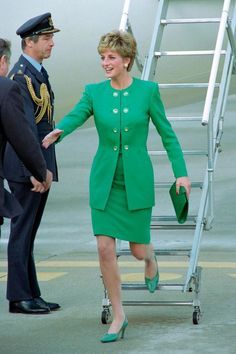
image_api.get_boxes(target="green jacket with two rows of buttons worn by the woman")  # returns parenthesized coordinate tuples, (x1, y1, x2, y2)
(57, 78, 187, 210)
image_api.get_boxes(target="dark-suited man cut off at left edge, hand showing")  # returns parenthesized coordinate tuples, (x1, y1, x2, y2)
(0, 38, 52, 233)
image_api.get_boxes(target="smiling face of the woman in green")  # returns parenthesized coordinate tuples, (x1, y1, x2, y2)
(101, 49, 130, 79)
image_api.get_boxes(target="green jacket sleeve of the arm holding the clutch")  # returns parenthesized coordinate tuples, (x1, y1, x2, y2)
(150, 84, 187, 178)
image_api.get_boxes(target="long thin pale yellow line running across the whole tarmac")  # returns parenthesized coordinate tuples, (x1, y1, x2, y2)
(0, 260, 236, 269)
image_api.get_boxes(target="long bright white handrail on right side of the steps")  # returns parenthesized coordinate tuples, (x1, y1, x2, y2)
(202, 0, 231, 125)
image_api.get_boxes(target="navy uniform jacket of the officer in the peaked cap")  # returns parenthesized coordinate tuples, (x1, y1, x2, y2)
(4, 56, 57, 182)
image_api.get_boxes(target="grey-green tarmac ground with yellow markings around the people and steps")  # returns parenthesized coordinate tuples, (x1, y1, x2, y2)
(0, 96, 236, 354)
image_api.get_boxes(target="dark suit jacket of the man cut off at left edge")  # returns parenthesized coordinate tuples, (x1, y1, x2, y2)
(0, 77, 46, 217)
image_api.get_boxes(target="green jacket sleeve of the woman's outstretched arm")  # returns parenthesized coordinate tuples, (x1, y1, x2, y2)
(56, 86, 93, 142)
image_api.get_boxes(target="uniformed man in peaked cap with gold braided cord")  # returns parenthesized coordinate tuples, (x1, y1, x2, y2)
(4, 13, 60, 314)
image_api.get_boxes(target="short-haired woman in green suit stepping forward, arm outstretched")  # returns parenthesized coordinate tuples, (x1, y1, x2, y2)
(43, 31, 190, 342)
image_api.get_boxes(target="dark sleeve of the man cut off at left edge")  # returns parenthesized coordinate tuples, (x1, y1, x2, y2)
(2, 82, 46, 182)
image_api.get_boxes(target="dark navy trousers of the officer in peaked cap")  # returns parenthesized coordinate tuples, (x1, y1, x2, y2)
(7, 182, 48, 301)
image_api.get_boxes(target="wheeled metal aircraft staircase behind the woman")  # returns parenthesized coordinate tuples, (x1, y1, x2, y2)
(102, 0, 236, 324)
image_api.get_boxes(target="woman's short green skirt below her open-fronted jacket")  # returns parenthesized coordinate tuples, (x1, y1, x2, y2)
(91, 154, 152, 244)
